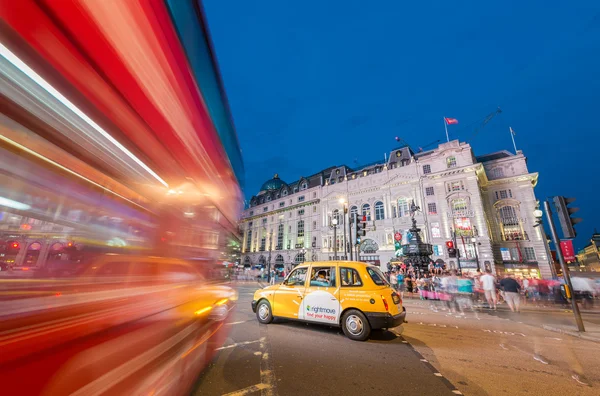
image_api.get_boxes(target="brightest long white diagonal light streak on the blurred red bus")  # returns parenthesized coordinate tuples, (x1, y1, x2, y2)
(0, 43, 169, 188)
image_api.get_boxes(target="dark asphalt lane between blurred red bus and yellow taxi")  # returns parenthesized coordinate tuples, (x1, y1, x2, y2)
(194, 285, 460, 396)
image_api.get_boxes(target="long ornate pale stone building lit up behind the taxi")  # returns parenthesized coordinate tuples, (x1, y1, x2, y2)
(240, 140, 551, 277)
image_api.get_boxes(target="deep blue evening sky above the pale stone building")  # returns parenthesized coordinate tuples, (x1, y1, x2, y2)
(204, 0, 600, 248)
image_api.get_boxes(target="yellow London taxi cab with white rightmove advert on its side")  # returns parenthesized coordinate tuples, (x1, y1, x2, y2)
(252, 261, 406, 341)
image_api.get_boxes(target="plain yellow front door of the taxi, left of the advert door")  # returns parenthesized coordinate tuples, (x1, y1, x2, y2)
(273, 267, 308, 319)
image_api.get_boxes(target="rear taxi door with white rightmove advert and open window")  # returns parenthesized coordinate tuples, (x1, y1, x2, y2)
(302, 264, 341, 325)
